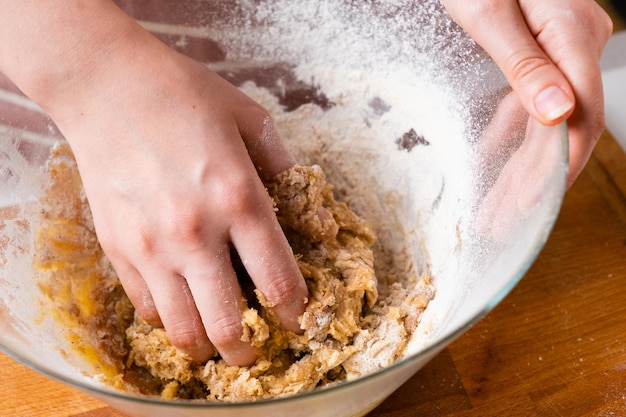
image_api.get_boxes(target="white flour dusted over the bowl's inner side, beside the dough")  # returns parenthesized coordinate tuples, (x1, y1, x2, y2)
(208, 0, 478, 352)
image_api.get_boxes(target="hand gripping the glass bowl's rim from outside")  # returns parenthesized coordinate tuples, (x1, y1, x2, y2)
(443, 0, 613, 186)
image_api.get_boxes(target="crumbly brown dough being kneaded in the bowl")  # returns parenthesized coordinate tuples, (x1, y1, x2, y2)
(36, 144, 434, 401)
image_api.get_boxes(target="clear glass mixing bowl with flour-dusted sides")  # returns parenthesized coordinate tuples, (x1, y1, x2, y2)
(0, 0, 568, 417)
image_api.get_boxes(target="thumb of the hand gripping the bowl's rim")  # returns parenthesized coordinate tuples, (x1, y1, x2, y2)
(445, 0, 575, 125)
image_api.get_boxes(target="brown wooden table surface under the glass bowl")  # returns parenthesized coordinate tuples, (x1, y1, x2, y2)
(0, 5, 626, 417)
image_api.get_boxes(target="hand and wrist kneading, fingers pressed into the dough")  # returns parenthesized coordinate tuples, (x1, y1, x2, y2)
(0, 0, 307, 365)
